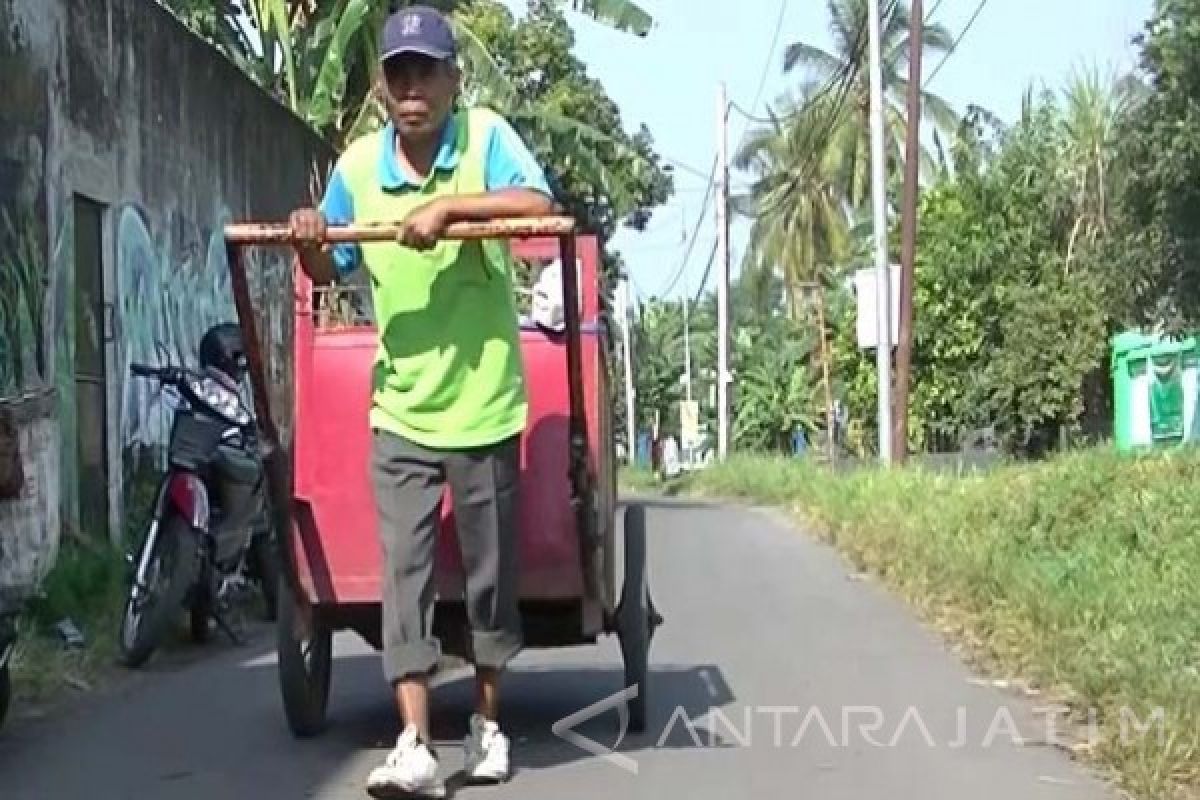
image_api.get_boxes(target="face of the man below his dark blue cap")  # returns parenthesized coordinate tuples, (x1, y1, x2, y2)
(383, 53, 458, 138)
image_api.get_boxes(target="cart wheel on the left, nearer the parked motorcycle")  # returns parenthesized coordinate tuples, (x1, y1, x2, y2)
(275, 577, 334, 738)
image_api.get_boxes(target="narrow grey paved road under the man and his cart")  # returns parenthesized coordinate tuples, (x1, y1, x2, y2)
(0, 503, 1108, 800)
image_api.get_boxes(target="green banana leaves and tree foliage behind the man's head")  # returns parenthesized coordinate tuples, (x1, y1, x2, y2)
(153, 0, 673, 245)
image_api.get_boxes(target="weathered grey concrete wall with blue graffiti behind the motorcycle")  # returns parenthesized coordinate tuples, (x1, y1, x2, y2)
(0, 0, 332, 575)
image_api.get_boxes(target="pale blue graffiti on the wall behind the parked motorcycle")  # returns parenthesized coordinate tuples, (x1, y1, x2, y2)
(115, 205, 292, 472)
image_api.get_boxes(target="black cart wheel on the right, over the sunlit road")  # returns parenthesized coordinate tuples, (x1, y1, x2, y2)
(617, 505, 659, 733)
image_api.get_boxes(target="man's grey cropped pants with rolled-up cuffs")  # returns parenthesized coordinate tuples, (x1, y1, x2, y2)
(371, 431, 522, 684)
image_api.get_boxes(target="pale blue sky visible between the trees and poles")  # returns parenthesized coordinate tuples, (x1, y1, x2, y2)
(506, 0, 1152, 295)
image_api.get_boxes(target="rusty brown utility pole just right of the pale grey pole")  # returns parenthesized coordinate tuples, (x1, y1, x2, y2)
(892, 0, 925, 463)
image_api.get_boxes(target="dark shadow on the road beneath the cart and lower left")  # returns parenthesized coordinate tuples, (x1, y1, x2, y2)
(7, 640, 736, 800)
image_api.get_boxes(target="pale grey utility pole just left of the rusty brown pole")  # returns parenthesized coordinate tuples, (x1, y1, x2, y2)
(866, 0, 892, 464)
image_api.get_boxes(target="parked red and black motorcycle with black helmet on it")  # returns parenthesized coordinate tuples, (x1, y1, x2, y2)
(119, 324, 280, 667)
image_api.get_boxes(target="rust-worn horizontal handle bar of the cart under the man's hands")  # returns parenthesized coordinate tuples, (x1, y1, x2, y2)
(224, 217, 575, 245)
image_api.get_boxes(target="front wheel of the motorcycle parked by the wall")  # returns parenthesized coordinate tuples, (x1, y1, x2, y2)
(118, 515, 199, 667)
